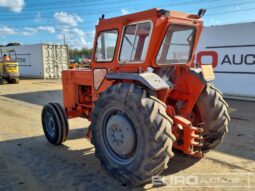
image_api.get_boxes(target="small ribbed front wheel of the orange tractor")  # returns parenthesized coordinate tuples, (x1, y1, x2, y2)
(41, 103, 69, 145)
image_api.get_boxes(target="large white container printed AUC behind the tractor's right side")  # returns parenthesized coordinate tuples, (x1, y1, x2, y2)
(197, 23, 255, 99)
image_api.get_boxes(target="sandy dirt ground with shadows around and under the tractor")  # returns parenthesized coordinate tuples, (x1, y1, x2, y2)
(0, 80, 255, 191)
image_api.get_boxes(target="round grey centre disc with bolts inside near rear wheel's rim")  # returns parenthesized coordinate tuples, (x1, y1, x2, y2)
(106, 113, 136, 159)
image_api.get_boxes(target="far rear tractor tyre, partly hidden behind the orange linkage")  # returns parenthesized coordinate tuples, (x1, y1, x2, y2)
(196, 84, 230, 152)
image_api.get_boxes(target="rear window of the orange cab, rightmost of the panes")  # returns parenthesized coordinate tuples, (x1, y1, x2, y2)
(157, 25, 196, 64)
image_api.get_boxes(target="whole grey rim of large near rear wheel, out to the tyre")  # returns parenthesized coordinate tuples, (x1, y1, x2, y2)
(103, 110, 139, 164)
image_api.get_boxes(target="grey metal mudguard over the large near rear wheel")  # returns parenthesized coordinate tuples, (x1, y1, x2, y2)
(106, 72, 172, 91)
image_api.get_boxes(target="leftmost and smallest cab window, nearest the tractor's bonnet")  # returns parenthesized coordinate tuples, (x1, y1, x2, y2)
(95, 30, 118, 62)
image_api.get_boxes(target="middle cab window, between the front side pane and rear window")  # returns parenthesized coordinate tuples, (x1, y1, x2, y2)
(119, 22, 152, 63)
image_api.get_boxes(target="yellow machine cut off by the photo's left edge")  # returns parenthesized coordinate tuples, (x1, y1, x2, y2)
(0, 50, 19, 84)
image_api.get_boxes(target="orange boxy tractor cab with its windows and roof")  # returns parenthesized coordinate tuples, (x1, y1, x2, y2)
(92, 9, 203, 72)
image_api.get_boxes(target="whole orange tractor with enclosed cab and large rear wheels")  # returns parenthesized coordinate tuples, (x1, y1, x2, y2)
(42, 9, 230, 185)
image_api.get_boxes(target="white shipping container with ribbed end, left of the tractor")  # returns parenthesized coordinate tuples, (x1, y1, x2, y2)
(2, 44, 69, 79)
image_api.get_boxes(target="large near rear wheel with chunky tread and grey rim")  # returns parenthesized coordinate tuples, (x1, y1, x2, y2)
(92, 83, 175, 185)
